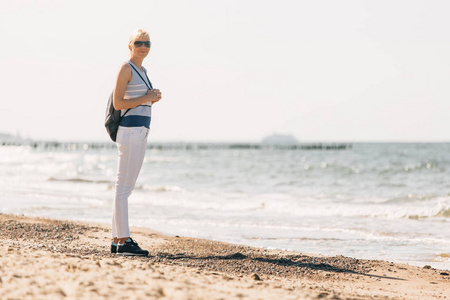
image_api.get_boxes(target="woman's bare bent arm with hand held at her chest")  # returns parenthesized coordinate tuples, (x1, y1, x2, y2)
(113, 64, 161, 110)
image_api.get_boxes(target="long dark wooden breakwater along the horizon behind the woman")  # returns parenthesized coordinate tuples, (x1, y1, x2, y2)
(0, 141, 352, 151)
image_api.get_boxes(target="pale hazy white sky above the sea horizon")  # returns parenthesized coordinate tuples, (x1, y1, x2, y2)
(0, 0, 450, 142)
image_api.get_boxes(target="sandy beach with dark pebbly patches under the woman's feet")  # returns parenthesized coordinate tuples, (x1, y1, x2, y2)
(0, 214, 450, 300)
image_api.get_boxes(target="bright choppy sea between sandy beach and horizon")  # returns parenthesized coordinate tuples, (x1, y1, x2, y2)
(0, 142, 450, 270)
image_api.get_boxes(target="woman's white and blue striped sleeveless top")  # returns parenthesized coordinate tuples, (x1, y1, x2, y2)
(119, 60, 152, 129)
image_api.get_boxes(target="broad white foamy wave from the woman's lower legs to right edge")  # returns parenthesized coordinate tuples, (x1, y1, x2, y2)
(126, 189, 450, 220)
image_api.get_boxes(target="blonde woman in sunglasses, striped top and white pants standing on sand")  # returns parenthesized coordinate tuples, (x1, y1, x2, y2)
(111, 30, 161, 256)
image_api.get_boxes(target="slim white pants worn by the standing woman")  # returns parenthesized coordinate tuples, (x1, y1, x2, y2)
(112, 126, 149, 238)
